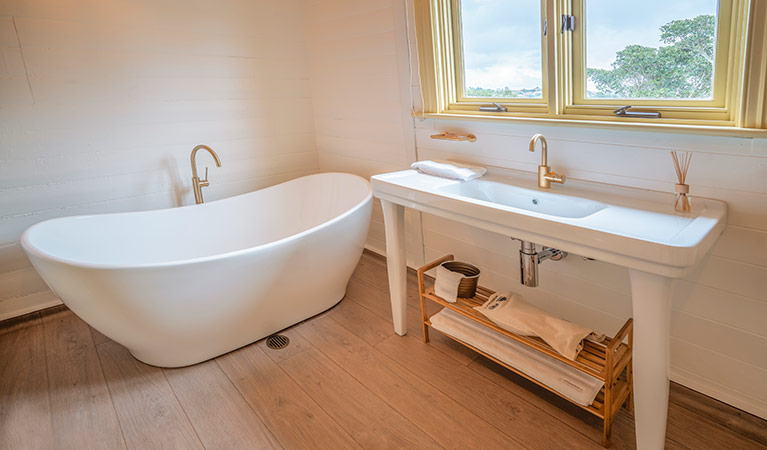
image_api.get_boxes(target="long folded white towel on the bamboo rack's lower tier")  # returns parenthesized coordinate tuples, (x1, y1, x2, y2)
(431, 308, 604, 406)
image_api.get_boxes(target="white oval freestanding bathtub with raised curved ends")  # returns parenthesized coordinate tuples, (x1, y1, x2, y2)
(21, 173, 372, 367)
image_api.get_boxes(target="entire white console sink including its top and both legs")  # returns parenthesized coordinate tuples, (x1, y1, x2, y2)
(371, 170, 727, 450)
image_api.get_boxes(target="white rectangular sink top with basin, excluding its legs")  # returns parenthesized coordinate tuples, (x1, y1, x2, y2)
(371, 170, 727, 278)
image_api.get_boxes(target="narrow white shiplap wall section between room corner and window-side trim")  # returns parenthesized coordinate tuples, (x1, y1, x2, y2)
(305, 0, 423, 264)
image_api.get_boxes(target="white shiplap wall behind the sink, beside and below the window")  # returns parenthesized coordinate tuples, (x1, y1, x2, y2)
(307, 0, 767, 417)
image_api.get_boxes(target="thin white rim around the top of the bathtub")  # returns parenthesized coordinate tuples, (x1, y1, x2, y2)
(20, 172, 373, 270)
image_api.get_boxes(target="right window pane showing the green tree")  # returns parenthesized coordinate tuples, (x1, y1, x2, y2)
(585, 0, 717, 100)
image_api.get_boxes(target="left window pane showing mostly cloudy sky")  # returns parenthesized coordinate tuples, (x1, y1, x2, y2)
(460, 0, 543, 98)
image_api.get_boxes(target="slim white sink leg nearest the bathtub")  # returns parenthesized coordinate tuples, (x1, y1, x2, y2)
(381, 200, 407, 336)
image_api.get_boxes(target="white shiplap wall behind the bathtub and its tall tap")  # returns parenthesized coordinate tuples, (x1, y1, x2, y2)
(0, 0, 318, 319)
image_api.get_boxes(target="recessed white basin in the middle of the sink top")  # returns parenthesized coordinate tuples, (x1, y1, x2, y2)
(438, 180, 607, 219)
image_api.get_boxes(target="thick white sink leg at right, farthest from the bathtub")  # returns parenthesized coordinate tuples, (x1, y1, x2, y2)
(629, 269, 671, 450)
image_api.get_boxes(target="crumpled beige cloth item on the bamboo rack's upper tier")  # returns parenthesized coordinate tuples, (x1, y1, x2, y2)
(474, 292, 605, 361)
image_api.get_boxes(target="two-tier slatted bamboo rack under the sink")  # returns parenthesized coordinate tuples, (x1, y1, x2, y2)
(418, 255, 634, 448)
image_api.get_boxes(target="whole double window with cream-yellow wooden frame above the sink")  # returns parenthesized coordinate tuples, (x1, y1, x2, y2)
(416, 0, 767, 132)
